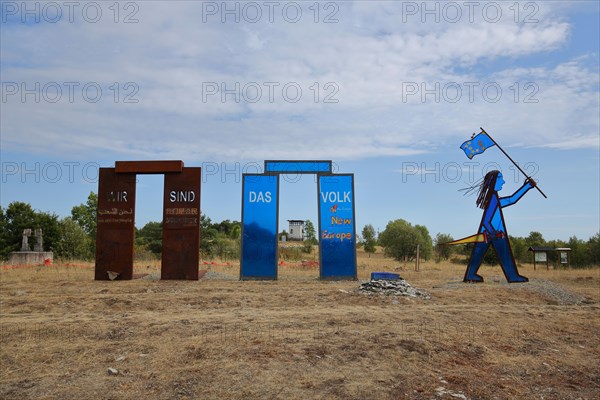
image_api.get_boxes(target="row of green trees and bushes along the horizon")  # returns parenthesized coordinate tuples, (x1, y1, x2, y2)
(0, 192, 600, 267)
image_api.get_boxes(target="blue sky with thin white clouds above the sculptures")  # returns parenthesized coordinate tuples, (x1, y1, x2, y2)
(0, 1, 600, 239)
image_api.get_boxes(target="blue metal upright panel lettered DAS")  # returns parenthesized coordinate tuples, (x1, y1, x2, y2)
(240, 174, 279, 279)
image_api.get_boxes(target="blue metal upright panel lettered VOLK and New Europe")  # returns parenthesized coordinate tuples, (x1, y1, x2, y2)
(318, 174, 356, 279)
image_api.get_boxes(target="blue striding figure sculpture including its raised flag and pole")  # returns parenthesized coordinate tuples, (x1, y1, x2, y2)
(444, 128, 546, 283)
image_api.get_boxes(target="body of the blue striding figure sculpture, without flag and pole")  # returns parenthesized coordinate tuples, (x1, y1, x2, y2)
(464, 170, 535, 283)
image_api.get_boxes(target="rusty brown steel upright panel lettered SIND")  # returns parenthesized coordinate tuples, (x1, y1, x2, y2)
(160, 167, 201, 280)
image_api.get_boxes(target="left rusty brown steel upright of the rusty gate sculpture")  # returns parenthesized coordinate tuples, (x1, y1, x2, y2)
(95, 168, 136, 280)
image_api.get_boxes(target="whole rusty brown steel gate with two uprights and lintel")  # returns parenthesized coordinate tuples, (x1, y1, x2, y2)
(95, 161, 201, 280)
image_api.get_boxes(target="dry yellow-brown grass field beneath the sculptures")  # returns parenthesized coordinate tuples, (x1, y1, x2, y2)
(0, 253, 600, 400)
